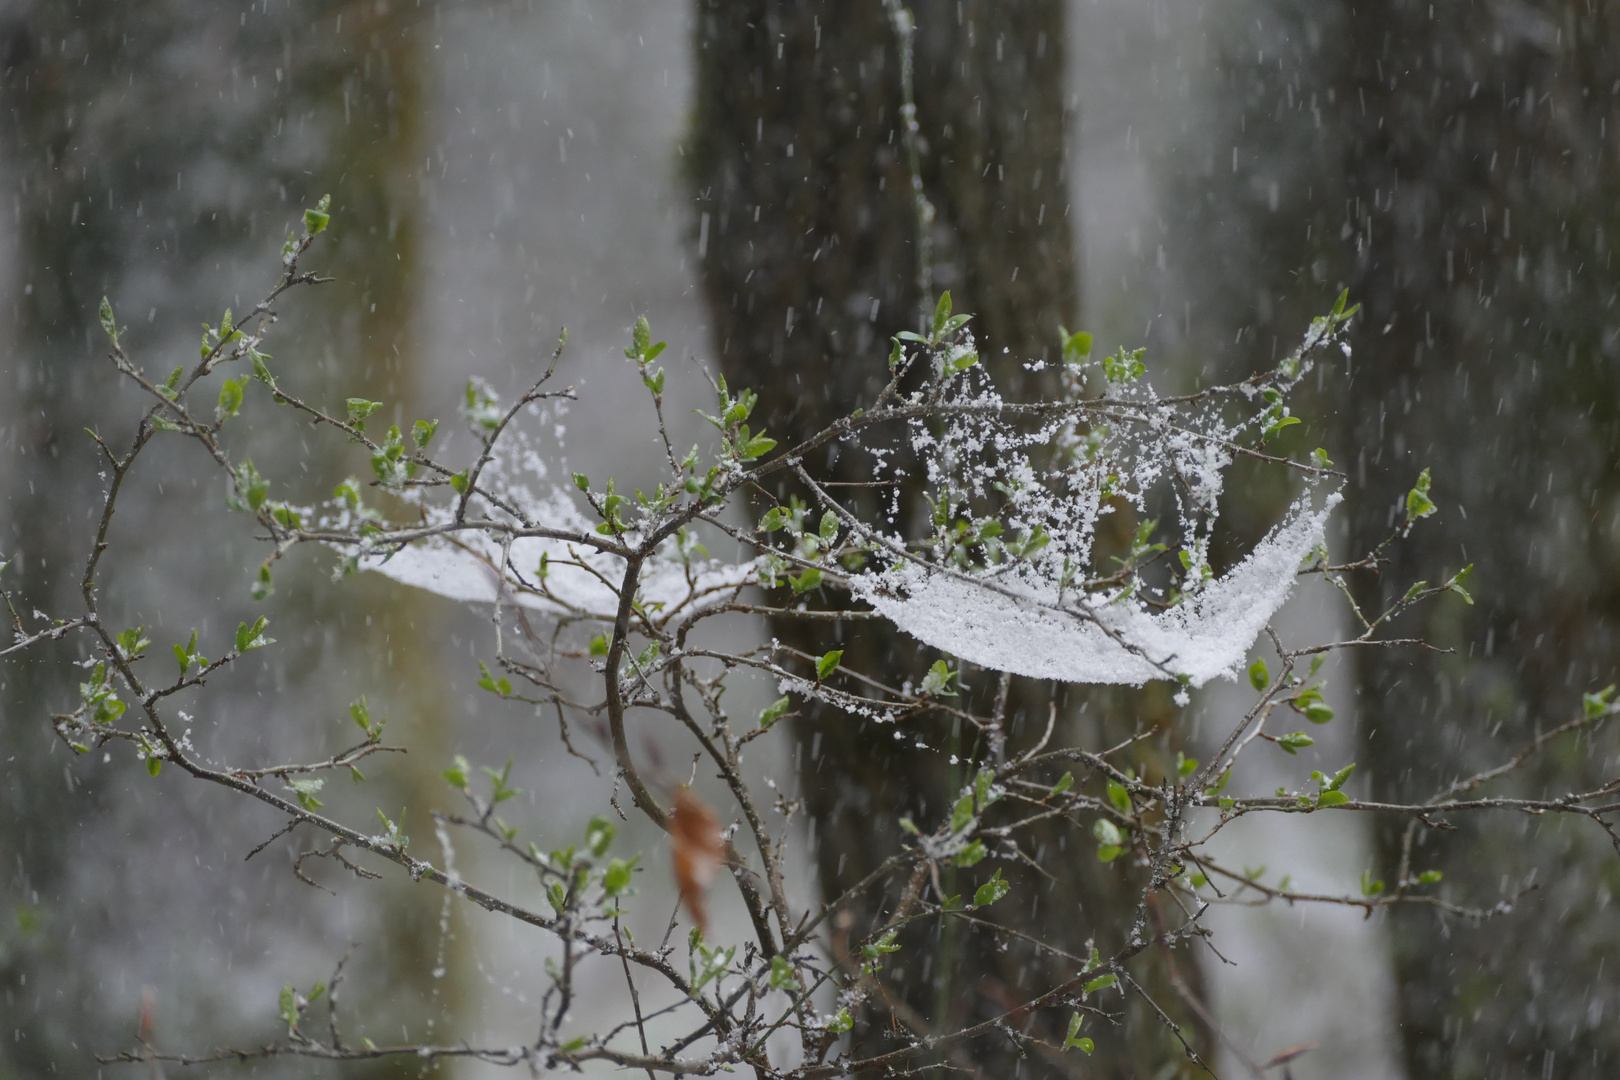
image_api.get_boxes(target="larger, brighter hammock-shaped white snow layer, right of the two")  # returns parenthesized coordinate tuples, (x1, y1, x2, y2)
(852, 494, 1340, 687)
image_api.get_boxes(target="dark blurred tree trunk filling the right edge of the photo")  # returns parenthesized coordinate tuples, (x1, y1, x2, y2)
(1348, 3, 1620, 1078)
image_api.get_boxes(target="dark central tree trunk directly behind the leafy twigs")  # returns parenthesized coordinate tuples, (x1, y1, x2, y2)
(687, 0, 1197, 1077)
